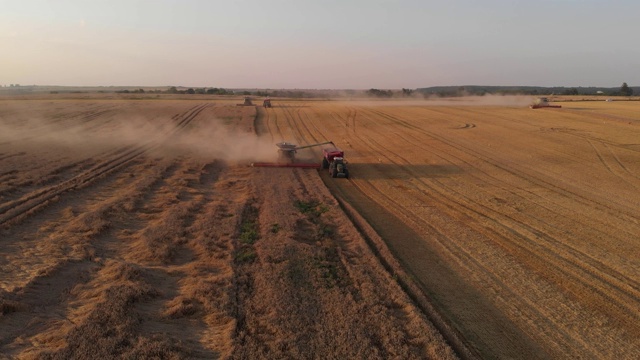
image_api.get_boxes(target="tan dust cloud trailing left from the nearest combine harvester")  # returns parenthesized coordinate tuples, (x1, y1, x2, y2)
(0, 113, 277, 163)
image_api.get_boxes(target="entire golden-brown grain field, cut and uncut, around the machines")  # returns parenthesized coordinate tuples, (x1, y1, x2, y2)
(0, 97, 640, 359)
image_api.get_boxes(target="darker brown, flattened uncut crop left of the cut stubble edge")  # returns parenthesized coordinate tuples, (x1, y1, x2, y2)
(0, 98, 460, 359)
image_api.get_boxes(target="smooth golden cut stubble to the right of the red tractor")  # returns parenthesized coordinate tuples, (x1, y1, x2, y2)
(267, 98, 640, 359)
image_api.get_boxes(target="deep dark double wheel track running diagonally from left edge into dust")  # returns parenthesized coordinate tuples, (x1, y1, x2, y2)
(0, 104, 209, 226)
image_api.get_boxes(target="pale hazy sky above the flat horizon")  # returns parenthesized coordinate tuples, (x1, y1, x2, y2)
(0, 0, 640, 89)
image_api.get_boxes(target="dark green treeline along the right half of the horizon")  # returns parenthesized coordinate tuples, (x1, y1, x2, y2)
(416, 83, 640, 97)
